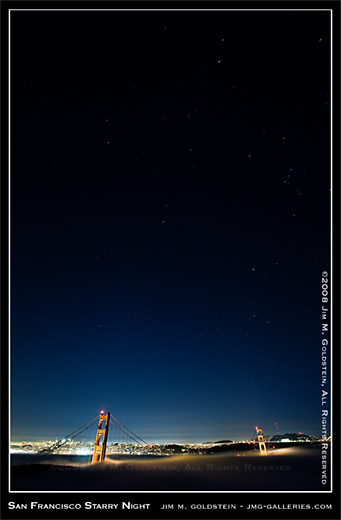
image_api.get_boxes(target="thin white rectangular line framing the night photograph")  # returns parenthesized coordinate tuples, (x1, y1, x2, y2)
(8, 9, 333, 494)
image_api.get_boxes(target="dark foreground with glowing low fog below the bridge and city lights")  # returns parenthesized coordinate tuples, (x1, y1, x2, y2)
(11, 446, 330, 491)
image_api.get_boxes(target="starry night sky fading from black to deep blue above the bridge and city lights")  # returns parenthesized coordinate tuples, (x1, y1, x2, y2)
(11, 11, 330, 442)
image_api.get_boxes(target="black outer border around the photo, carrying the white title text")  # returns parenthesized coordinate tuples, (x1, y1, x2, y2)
(1, 0, 341, 520)
